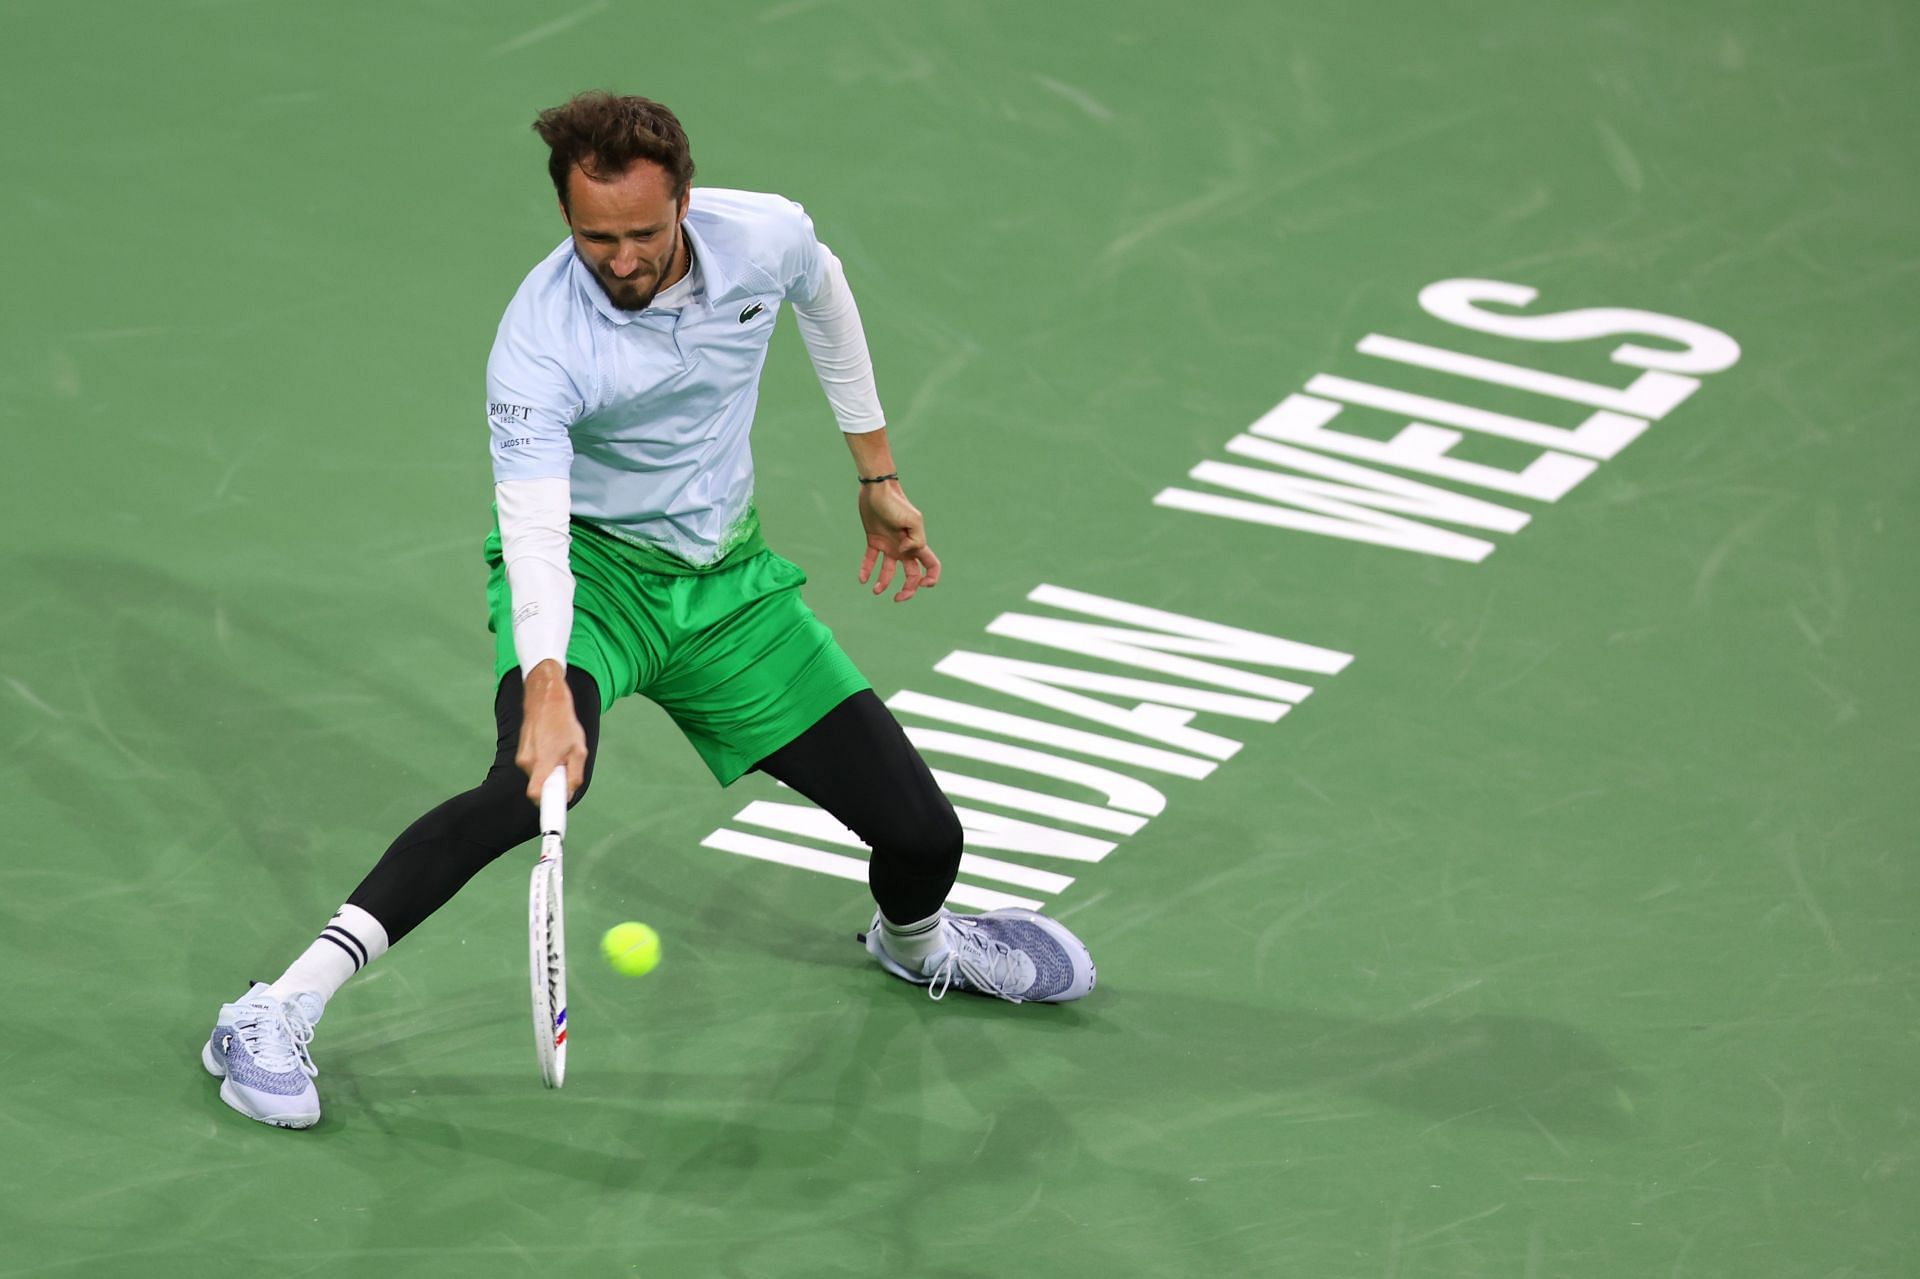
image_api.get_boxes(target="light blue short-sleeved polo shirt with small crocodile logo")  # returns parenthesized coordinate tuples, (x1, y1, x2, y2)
(486, 186, 829, 567)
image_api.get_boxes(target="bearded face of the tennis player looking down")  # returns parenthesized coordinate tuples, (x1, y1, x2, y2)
(561, 159, 687, 311)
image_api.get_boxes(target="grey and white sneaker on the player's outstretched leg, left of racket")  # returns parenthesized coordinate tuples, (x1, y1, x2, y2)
(200, 981, 323, 1127)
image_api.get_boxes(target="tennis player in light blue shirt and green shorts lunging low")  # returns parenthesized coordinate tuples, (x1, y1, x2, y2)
(202, 92, 1094, 1127)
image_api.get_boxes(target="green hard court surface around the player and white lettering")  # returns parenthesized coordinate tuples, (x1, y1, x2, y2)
(0, 0, 1920, 1279)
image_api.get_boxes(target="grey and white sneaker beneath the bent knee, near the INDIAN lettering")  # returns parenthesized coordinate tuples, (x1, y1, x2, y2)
(860, 908, 1094, 1004)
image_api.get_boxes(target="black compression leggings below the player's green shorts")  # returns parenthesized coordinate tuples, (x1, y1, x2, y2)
(348, 668, 962, 943)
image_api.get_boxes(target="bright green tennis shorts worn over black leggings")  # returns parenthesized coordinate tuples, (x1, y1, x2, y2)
(486, 520, 872, 785)
